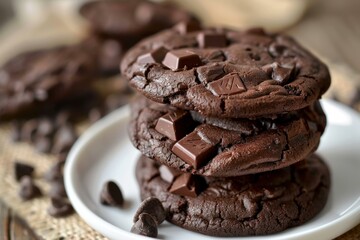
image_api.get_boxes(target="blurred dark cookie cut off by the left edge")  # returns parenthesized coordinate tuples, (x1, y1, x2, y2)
(0, 45, 95, 119)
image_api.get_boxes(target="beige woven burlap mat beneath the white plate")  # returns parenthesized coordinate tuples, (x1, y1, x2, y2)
(0, 62, 360, 240)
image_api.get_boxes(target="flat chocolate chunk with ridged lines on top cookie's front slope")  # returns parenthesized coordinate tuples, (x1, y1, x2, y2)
(208, 73, 246, 96)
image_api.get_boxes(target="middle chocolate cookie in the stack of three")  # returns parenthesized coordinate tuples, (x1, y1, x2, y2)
(129, 97, 326, 177)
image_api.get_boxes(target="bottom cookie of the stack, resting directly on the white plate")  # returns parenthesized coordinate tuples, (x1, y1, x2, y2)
(136, 155, 330, 237)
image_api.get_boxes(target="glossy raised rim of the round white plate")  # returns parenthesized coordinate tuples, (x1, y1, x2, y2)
(64, 99, 360, 240)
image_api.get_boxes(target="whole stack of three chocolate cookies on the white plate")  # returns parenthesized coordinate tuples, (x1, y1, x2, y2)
(121, 22, 330, 236)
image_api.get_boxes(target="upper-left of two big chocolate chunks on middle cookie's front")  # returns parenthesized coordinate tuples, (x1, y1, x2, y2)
(155, 110, 194, 141)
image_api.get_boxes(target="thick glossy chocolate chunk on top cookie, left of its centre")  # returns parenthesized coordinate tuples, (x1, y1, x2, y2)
(162, 49, 201, 71)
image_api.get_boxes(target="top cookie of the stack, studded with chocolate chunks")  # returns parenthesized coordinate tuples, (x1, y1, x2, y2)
(121, 23, 330, 118)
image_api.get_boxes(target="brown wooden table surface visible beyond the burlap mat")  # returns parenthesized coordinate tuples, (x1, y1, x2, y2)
(0, 0, 360, 240)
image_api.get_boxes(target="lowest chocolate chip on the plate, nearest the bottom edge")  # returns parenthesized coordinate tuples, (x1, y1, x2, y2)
(131, 213, 158, 238)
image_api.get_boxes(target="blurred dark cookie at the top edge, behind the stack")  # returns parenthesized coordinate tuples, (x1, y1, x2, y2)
(80, 0, 198, 42)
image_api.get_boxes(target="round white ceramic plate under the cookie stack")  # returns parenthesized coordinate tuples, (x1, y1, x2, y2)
(65, 101, 360, 240)
